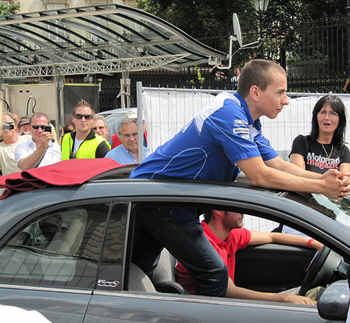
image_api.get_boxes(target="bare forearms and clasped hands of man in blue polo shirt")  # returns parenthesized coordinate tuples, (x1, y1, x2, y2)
(237, 157, 347, 199)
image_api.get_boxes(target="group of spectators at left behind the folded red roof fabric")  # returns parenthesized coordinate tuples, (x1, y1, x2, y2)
(0, 100, 147, 176)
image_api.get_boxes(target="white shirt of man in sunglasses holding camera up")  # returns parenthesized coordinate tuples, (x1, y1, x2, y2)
(15, 139, 61, 167)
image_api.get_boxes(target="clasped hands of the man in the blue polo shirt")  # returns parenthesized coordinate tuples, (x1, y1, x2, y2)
(321, 169, 350, 201)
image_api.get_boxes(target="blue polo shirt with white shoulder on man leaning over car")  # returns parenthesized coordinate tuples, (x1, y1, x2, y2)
(130, 92, 277, 221)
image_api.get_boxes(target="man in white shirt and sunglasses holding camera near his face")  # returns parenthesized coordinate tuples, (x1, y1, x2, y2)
(15, 112, 61, 170)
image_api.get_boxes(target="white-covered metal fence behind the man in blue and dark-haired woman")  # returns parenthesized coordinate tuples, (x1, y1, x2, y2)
(138, 87, 350, 160)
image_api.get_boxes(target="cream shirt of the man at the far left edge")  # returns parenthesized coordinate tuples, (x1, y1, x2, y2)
(0, 135, 32, 175)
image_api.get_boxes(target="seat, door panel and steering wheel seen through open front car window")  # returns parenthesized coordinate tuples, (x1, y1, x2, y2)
(128, 206, 349, 302)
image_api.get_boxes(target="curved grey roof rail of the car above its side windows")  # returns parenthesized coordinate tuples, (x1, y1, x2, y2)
(0, 174, 350, 254)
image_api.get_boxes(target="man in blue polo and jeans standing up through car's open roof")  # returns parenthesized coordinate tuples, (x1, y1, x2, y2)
(130, 59, 348, 296)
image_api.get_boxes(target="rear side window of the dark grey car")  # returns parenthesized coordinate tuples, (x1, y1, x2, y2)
(0, 203, 109, 288)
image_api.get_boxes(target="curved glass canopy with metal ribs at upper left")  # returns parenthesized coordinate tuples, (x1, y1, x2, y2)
(0, 4, 227, 78)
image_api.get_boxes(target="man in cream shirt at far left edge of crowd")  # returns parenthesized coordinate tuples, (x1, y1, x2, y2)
(0, 112, 32, 175)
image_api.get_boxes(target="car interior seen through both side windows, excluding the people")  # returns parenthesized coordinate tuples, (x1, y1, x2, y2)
(0, 202, 349, 308)
